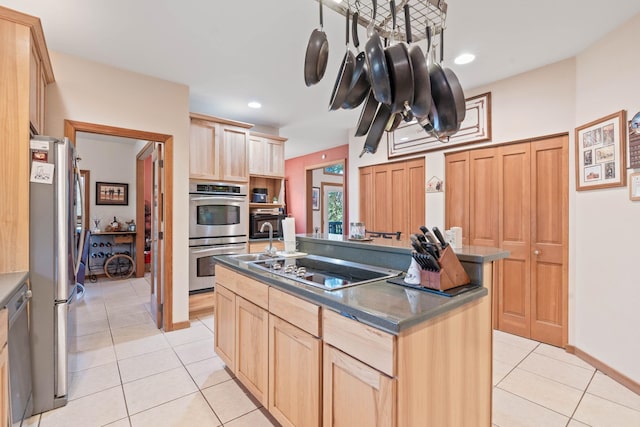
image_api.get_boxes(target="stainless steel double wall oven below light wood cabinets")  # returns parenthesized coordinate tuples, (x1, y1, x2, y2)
(189, 182, 249, 293)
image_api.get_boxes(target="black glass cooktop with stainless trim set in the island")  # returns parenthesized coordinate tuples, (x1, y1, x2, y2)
(244, 254, 401, 291)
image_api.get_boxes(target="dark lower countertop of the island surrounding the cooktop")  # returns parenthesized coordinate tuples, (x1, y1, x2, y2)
(216, 255, 488, 335)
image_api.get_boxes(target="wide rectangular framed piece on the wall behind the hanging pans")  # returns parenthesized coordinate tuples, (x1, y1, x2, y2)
(387, 92, 491, 158)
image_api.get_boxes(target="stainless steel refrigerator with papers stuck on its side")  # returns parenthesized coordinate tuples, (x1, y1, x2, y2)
(29, 137, 84, 413)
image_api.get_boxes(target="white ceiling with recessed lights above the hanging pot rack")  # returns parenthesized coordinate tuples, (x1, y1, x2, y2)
(5, 0, 640, 158)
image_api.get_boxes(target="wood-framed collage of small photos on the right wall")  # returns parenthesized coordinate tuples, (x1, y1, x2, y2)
(575, 110, 627, 191)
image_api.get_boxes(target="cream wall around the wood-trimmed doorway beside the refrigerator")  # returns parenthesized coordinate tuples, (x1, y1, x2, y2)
(45, 51, 189, 322)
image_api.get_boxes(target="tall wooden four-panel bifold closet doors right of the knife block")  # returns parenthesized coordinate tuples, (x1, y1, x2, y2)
(445, 135, 569, 346)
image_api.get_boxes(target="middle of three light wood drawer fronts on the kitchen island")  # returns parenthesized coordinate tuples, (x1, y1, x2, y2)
(269, 288, 320, 337)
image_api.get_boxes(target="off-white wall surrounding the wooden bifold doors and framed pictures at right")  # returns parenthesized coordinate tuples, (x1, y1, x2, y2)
(348, 15, 640, 382)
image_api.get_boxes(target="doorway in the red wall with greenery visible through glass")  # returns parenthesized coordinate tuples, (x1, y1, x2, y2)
(305, 159, 348, 234)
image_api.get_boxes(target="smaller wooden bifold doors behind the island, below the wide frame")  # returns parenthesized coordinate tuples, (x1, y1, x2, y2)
(359, 158, 425, 236)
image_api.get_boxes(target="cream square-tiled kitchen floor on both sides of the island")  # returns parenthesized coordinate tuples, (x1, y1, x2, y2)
(26, 279, 640, 427)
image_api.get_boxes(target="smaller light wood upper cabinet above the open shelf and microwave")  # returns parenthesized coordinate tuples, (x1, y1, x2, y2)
(249, 132, 287, 178)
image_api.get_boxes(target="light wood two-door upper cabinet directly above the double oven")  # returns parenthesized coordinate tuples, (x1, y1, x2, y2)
(189, 113, 253, 182)
